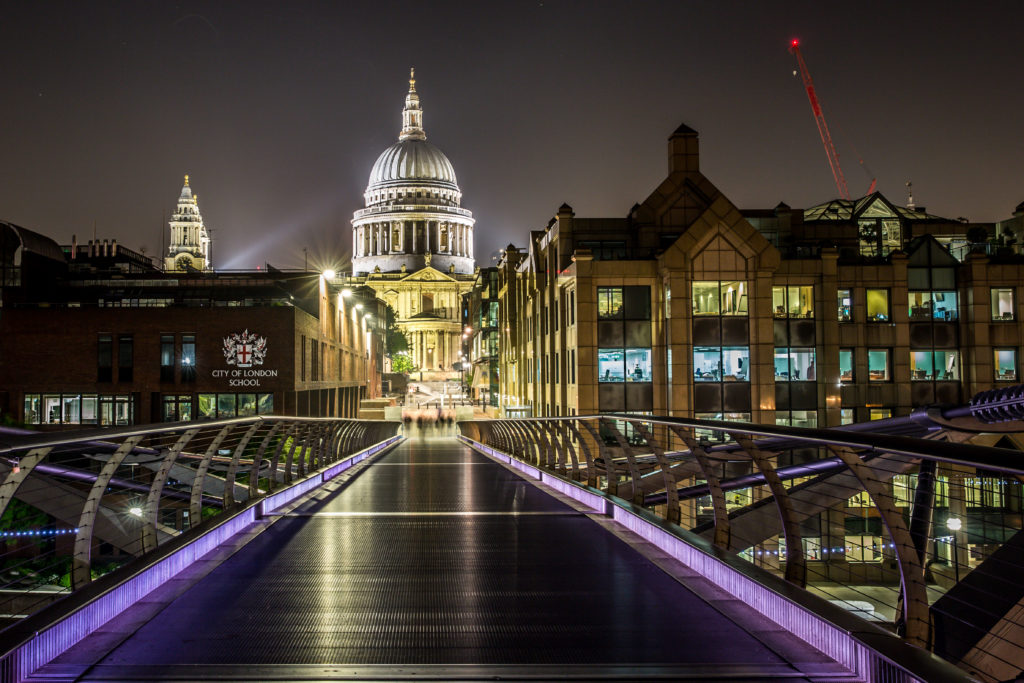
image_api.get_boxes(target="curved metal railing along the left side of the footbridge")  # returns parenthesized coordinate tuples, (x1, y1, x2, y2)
(0, 416, 400, 627)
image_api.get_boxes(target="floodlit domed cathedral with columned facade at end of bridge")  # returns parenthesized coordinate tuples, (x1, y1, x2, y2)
(352, 74, 475, 372)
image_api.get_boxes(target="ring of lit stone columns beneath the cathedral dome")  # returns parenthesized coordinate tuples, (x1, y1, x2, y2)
(354, 220, 473, 258)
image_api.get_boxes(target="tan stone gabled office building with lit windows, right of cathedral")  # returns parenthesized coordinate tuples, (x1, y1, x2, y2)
(498, 120, 1024, 426)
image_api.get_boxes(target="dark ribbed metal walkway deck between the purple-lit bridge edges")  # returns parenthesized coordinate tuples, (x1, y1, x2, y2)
(29, 436, 843, 681)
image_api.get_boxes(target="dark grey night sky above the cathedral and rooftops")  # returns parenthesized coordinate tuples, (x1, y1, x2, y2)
(0, 0, 1024, 268)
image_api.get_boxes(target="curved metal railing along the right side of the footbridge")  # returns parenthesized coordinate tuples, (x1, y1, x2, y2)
(459, 397, 1024, 681)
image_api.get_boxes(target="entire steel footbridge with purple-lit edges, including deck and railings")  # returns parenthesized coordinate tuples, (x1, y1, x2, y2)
(0, 387, 1024, 682)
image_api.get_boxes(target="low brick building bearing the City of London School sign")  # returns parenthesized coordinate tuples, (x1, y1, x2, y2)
(0, 223, 383, 428)
